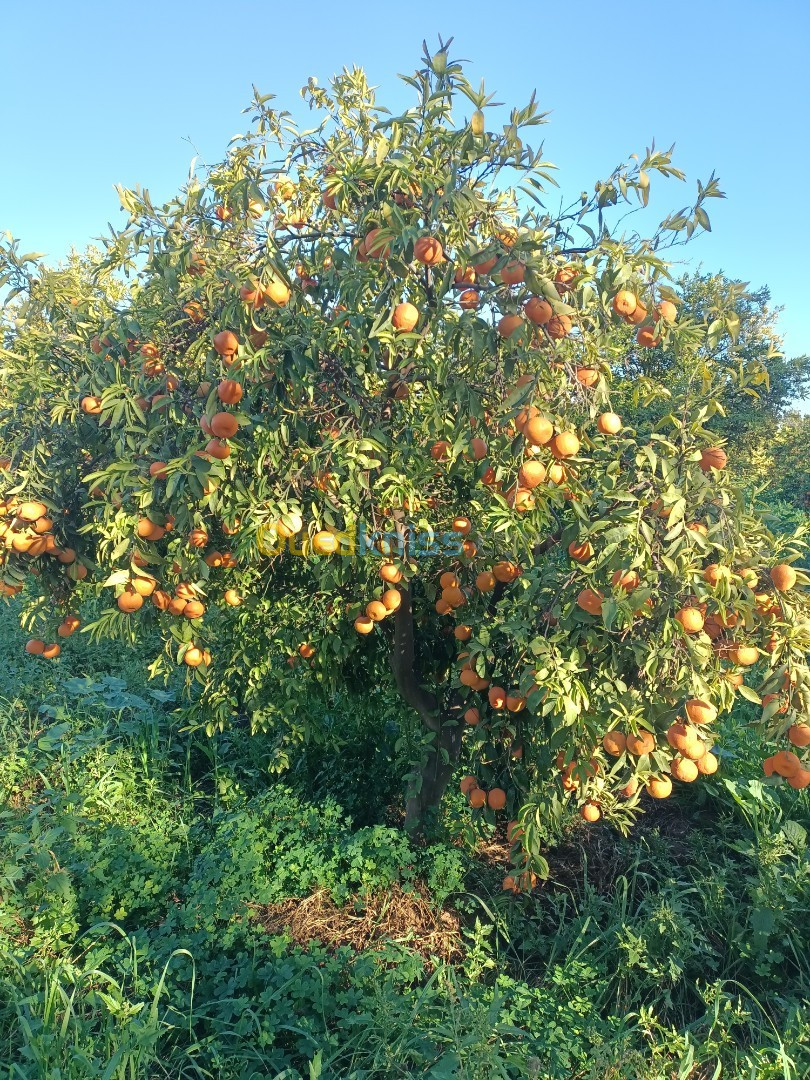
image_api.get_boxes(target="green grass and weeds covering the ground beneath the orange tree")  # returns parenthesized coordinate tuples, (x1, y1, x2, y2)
(0, 608, 810, 1080)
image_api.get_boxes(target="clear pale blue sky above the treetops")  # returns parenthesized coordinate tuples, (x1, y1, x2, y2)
(0, 0, 810, 365)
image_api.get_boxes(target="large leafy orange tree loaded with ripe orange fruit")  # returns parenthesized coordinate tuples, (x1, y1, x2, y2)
(0, 46, 810, 887)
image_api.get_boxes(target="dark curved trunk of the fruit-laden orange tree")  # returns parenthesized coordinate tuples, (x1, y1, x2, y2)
(391, 589, 461, 832)
